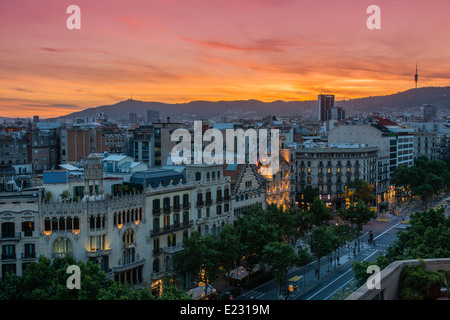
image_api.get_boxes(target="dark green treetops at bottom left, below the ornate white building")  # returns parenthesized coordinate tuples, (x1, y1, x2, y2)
(0, 256, 191, 300)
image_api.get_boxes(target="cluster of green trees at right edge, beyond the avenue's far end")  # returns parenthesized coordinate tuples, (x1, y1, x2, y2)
(391, 156, 450, 203)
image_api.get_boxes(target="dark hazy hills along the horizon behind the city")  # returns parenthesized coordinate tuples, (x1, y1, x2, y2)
(49, 87, 450, 121)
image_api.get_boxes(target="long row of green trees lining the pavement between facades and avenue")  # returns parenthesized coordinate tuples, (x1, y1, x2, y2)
(172, 198, 375, 295)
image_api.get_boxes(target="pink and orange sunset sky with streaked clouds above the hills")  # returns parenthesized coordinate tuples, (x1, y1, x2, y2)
(0, 0, 450, 118)
